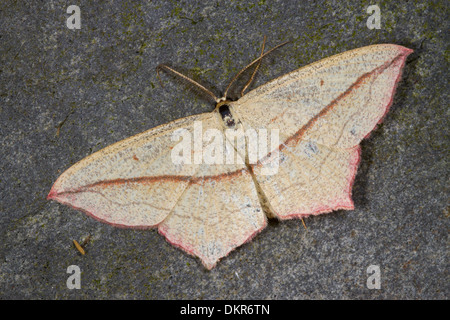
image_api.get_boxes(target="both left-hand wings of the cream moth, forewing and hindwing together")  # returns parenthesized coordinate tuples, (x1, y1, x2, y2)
(48, 113, 266, 269)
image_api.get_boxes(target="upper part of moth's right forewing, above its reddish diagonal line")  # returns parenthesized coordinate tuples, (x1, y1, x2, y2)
(232, 44, 412, 141)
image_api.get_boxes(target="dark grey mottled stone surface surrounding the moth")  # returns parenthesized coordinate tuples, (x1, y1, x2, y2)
(0, 0, 450, 299)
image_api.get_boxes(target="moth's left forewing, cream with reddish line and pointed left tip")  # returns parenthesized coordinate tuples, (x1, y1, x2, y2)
(48, 114, 216, 227)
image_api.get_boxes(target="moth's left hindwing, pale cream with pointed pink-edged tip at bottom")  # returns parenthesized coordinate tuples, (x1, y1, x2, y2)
(158, 156, 266, 269)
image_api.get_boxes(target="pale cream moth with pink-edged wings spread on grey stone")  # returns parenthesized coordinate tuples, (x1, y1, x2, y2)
(48, 44, 412, 269)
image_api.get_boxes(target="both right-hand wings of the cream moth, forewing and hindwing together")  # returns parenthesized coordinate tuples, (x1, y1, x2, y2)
(232, 45, 412, 219)
